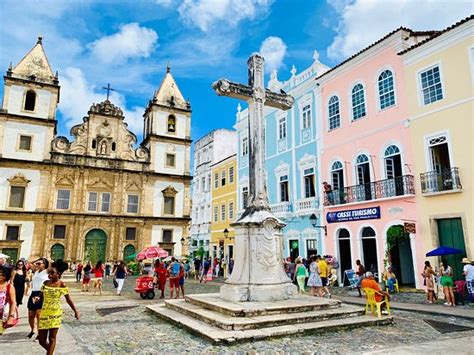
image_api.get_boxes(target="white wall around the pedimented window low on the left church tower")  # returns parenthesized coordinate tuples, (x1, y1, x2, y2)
(0, 168, 40, 211)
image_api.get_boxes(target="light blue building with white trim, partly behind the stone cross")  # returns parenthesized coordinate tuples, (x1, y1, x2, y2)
(234, 51, 328, 259)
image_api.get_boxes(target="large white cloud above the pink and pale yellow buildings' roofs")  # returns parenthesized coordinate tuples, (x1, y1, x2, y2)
(327, 0, 472, 60)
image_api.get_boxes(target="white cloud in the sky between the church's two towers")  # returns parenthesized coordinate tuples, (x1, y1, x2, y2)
(59, 67, 145, 136)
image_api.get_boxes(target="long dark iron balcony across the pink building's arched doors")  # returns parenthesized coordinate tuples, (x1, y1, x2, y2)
(324, 175, 415, 206)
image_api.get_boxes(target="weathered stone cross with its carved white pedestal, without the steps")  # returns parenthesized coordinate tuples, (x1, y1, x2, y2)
(212, 54, 296, 301)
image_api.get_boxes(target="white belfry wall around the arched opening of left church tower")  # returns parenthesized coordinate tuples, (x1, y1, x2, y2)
(7, 85, 52, 119)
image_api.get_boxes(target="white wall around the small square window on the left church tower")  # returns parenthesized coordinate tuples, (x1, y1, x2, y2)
(2, 121, 51, 161)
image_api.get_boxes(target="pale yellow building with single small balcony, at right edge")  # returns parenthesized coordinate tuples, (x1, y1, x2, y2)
(399, 16, 474, 278)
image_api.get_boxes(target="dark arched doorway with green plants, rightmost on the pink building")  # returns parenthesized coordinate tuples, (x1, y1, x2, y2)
(387, 225, 415, 286)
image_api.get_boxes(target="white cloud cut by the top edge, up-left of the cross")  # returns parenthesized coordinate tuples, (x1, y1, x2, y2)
(178, 0, 273, 32)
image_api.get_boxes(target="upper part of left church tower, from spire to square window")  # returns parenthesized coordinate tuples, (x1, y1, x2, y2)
(0, 37, 60, 161)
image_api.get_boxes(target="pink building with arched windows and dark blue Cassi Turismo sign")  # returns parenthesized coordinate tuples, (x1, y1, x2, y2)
(316, 28, 429, 287)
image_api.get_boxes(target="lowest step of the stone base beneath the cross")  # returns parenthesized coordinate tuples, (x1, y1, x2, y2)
(147, 305, 393, 344)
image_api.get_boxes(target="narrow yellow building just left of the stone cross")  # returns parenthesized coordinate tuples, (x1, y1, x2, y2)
(210, 154, 237, 272)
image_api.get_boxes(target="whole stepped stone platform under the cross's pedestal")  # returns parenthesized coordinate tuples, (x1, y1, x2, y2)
(147, 294, 393, 343)
